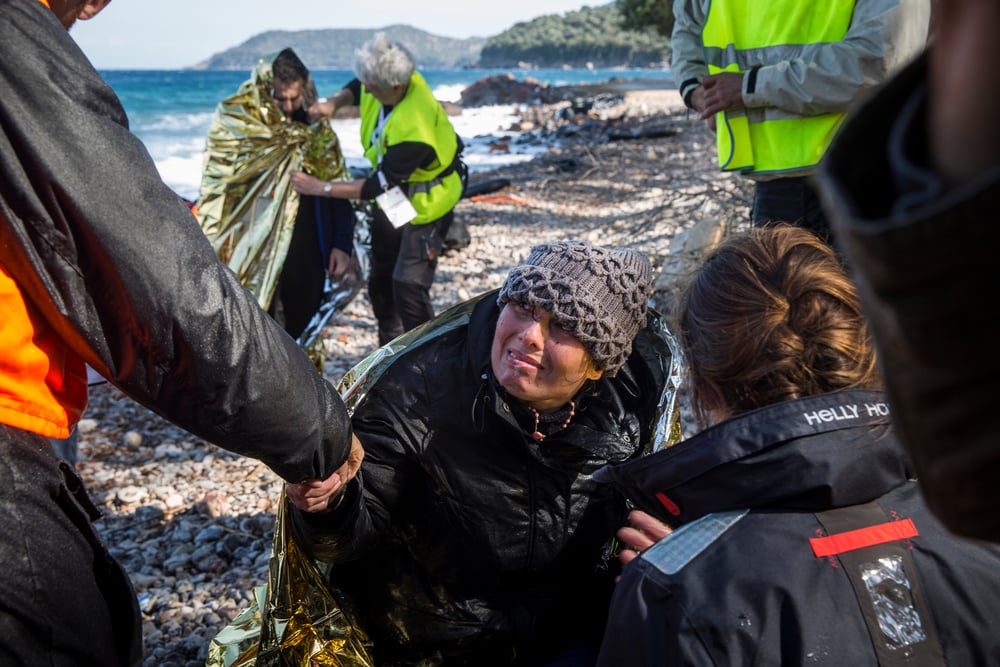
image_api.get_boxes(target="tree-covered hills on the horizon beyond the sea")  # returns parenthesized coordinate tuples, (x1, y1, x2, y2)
(192, 0, 673, 70)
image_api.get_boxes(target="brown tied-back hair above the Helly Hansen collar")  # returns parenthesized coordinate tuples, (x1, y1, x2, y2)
(677, 225, 879, 424)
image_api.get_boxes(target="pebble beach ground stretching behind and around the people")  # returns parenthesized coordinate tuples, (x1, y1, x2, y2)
(77, 89, 752, 667)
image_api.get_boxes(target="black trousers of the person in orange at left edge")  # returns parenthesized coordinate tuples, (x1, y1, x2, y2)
(0, 424, 142, 667)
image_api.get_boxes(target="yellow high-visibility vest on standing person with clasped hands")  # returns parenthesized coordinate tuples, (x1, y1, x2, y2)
(702, 0, 854, 174)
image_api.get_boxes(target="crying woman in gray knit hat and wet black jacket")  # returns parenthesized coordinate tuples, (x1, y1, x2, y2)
(292, 241, 670, 665)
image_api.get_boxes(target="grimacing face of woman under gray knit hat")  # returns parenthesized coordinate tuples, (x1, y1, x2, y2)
(490, 301, 601, 410)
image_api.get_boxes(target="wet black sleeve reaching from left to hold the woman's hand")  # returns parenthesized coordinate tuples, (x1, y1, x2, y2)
(0, 0, 350, 482)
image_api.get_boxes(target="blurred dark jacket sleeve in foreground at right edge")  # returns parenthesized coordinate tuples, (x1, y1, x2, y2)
(820, 56, 1000, 542)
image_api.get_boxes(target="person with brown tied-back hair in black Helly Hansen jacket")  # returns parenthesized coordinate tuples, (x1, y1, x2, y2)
(596, 226, 1000, 667)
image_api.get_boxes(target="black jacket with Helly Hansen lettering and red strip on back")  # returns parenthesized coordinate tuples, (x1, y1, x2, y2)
(598, 391, 1000, 667)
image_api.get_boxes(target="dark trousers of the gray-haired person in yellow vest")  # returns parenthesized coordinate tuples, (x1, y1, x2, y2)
(368, 210, 454, 345)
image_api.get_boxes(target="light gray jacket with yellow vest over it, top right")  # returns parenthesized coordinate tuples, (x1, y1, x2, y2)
(672, 0, 930, 180)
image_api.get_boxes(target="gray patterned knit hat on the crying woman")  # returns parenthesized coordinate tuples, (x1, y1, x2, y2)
(497, 241, 653, 377)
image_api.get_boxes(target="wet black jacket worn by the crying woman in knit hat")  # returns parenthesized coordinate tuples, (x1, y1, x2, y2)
(295, 293, 665, 664)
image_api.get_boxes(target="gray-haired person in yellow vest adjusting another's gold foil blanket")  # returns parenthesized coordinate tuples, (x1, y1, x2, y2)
(291, 32, 465, 345)
